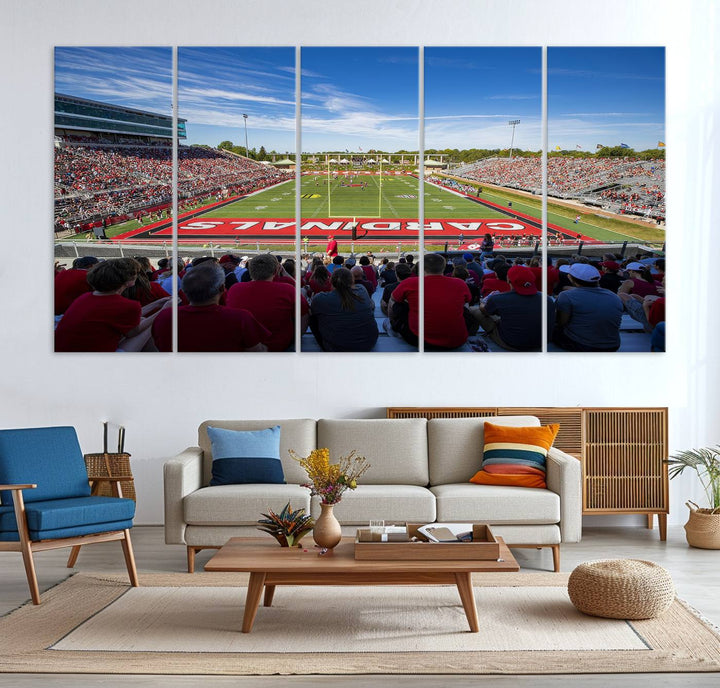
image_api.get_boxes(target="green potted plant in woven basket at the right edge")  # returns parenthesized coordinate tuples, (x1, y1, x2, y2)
(666, 446, 720, 549)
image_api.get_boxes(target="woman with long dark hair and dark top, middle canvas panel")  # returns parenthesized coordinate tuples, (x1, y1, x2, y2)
(310, 267, 378, 351)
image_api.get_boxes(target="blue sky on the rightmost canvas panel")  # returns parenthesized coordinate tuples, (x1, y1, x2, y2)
(548, 47, 665, 152)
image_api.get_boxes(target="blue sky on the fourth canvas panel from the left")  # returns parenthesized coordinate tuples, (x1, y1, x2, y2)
(425, 48, 542, 150)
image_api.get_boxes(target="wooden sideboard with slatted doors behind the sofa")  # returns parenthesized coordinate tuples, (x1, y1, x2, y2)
(386, 406, 669, 540)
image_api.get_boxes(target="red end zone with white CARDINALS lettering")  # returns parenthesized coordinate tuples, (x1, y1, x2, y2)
(115, 217, 595, 244)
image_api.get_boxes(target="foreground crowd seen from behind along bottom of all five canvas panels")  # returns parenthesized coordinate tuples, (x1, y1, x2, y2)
(55, 246, 665, 352)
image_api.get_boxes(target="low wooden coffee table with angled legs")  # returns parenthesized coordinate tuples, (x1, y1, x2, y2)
(205, 537, 520, 633)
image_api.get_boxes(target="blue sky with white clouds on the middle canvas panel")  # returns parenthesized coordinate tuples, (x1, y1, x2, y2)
(301, 47, 418, 152)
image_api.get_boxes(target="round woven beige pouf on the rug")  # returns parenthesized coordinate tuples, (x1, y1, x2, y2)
(568, 559, 675, 619)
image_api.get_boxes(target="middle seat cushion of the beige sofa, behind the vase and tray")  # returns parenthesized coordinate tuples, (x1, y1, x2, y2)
(311, 484, 435, 526)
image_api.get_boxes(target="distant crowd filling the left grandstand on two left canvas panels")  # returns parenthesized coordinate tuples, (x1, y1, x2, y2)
(55, 145, 293, 229)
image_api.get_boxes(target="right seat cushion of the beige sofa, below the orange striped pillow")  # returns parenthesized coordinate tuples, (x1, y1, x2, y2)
(430, 483, 560, 524)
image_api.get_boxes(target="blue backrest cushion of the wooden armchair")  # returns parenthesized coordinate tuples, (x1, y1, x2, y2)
(0, 426, 90, 505)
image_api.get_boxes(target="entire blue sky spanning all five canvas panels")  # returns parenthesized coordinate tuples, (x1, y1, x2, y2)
(55, 47, 665, 152)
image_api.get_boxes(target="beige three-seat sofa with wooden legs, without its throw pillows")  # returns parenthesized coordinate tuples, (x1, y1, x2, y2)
(164, 416, 582, 573)
